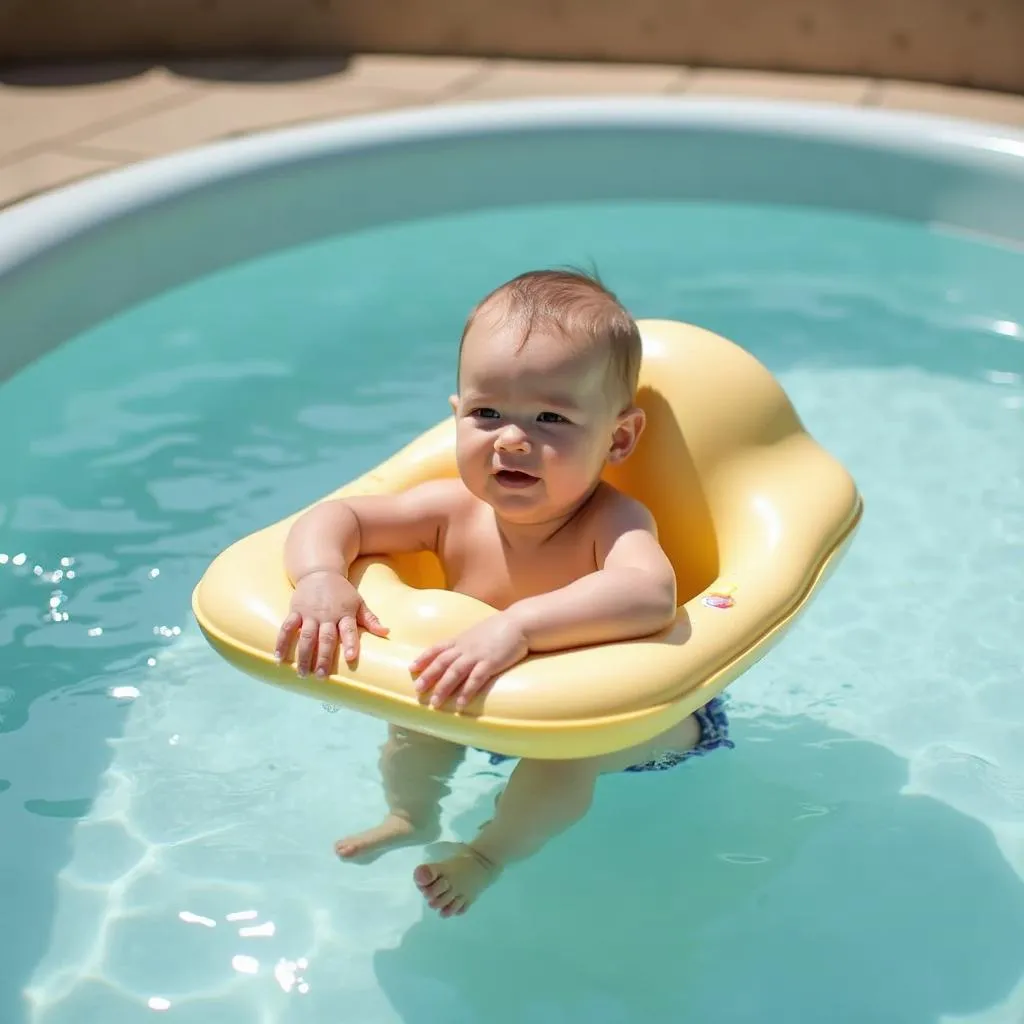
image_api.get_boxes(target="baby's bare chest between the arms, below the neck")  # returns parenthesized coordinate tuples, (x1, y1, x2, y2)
(444, 537, 597, 608)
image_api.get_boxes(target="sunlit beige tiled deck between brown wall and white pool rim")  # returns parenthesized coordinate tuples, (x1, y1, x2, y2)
(6, 55, 1024, 207)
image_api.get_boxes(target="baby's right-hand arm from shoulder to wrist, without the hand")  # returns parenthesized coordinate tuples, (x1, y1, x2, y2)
(505, 498, 676, 651)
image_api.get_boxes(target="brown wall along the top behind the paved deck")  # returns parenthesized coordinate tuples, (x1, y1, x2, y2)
(0, 0, 1024, 93)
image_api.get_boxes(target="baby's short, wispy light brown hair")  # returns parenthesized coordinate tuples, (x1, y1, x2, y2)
(459, 267, 641, 404)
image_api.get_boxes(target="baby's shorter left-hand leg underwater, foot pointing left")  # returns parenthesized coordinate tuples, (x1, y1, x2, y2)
(335, 725, 466, 859)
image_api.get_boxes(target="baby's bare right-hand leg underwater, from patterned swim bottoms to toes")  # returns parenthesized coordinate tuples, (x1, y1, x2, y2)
(414, 716, 700, 918)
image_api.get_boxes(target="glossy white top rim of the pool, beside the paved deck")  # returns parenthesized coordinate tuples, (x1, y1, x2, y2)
(0, 96, 1024, 274)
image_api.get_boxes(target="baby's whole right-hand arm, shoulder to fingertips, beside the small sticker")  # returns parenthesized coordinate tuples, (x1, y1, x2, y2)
(413, 496, 676, 710)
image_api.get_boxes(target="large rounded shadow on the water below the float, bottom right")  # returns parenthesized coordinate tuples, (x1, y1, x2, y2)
(375, 719, 1024, 1024)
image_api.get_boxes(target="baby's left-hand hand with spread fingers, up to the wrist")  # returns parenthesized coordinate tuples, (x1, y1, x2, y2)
(274, 571, 388, 677)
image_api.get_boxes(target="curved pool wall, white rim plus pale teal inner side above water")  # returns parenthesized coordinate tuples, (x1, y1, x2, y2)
(0, 98, 1024, 379)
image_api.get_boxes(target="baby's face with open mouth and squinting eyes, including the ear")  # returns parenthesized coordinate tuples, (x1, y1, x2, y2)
(452, 316, 632, 523)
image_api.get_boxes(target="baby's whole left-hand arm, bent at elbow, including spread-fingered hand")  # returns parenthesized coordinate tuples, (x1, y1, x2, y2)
(275, 480, 455, 675)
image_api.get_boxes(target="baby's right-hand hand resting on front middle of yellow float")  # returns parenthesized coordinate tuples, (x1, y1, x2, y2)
(410, 613, 529, 711)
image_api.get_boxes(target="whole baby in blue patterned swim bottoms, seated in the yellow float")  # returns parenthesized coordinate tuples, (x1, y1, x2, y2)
(278, 270, 731, 916)
